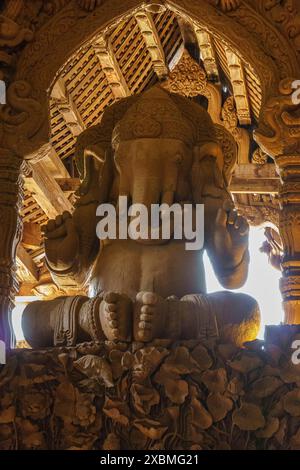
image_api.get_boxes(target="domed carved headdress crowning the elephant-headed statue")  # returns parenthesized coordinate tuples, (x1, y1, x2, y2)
(75, 85, 232, 184)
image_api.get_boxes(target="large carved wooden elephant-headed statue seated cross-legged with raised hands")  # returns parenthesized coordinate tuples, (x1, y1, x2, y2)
(23, 86, 260, 347)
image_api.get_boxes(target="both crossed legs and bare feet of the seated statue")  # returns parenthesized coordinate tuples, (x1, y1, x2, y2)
(22, 291, 260, 348)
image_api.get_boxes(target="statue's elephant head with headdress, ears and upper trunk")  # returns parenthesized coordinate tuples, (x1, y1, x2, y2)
(75, 86, 237, 227)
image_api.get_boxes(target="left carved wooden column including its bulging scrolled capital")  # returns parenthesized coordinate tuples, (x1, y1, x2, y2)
(0, 80, 47, 350)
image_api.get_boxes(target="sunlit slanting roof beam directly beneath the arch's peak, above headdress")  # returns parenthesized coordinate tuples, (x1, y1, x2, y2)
(135, 10, 169, 80)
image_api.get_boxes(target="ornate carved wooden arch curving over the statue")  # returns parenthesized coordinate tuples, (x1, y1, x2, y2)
(1, 0, 300, 159)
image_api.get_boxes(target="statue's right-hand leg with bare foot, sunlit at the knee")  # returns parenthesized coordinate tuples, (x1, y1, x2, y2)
(134, 291, 260, 346)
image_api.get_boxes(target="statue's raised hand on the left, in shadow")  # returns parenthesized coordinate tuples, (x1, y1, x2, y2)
(44, 212, 79, 271)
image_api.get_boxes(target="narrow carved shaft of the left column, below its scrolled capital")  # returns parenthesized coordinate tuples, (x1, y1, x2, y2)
(0, 149, 22, 350)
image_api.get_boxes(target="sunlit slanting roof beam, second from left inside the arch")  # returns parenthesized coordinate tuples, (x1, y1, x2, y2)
(92, 36, 131, 99)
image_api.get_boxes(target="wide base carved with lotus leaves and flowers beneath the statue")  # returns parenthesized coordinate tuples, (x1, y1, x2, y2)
(0, 336, 300, 450)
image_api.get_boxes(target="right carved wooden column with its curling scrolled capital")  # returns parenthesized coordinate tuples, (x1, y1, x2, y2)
(255, 79, 300, 325)
